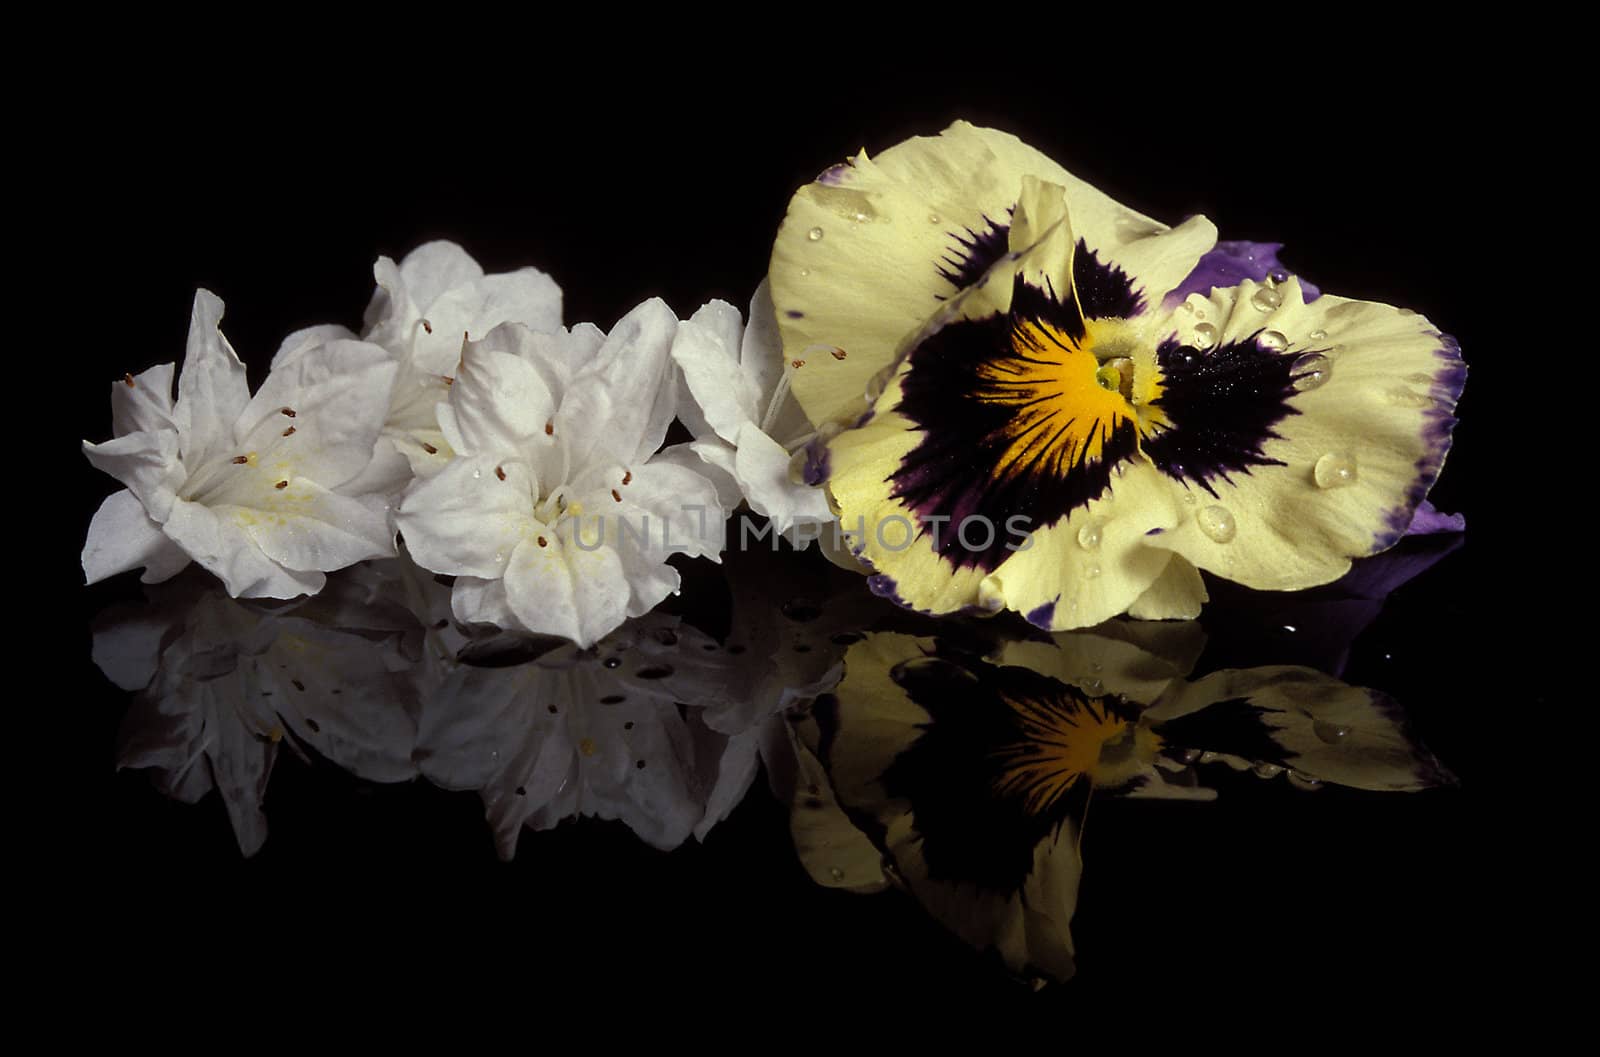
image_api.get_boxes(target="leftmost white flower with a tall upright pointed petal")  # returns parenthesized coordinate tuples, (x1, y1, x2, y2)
(83, 289, 395, 598)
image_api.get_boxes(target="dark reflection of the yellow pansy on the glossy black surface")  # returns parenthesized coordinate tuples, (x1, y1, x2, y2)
(794, 622, 1450, 979)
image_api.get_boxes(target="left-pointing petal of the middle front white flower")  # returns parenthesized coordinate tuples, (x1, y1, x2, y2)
(395, 456, 540, 580)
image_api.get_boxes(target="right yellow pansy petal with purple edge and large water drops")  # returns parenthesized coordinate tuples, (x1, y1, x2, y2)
(1146, 280, 1466, 590)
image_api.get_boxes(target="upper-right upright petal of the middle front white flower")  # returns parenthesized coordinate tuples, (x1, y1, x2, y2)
(555, 297, 678, 467)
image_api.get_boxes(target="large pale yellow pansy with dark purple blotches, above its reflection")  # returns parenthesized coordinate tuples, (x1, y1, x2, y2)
(771, 125, 1464, 628)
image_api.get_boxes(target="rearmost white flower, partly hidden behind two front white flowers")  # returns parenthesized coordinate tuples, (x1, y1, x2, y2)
(272, 241, 562, 493)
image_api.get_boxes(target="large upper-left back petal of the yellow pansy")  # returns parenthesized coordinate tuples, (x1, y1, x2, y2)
(770, 122, 1214, 422)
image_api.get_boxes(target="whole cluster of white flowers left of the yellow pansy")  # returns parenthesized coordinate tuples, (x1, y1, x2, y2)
(83, 241, 830, 646)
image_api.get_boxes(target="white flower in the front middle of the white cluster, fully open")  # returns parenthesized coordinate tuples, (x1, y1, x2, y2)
(397, 301, 723, 646)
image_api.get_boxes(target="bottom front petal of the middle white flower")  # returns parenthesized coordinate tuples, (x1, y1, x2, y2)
(506, 521, 629, 646)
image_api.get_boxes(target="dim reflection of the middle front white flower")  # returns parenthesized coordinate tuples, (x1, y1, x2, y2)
(418, 614, 758, 859)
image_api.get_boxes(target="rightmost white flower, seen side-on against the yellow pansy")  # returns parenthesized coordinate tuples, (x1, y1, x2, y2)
(672, 281, 835, 542)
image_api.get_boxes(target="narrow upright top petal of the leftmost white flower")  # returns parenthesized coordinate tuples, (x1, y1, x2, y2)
(173, 289, 250, 465)
